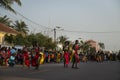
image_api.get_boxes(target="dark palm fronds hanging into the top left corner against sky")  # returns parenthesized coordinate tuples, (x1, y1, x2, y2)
(0, 0, 21, 13)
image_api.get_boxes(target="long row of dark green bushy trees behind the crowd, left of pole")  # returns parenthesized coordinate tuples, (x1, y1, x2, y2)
(5, 33, 56, 50)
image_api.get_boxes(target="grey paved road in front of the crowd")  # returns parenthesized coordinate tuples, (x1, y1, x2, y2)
(0, 62, 120, 80)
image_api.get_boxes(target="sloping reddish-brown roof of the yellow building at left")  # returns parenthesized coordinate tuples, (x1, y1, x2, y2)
(0, 23, 18, 34)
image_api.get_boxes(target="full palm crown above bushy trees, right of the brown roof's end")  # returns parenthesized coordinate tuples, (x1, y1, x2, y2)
(14, 20, 29, 36)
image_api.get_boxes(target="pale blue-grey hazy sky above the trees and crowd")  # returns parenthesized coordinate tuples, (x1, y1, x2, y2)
(1, 0, 120, 50)
